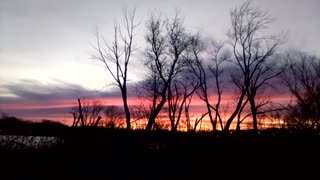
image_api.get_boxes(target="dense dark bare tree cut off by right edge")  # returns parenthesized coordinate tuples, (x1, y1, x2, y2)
(282, 52, 320, 129)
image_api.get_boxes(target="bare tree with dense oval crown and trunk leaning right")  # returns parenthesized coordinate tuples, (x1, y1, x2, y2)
(145, 14, 188, 130)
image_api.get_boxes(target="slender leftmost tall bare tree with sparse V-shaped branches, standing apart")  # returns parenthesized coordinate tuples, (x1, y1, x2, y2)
(93, 8, 138, 129)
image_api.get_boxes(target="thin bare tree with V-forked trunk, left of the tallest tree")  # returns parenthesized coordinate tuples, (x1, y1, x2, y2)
(188, 35, 229, 131)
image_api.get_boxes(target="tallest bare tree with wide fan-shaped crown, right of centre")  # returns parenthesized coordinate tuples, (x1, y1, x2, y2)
(229, 1, 284, 130)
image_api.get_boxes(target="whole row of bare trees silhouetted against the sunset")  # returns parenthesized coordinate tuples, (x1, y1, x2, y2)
(72, 1, 320, 131)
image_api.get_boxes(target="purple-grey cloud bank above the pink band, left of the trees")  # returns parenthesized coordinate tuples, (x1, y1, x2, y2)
(0, 79, 138, 104)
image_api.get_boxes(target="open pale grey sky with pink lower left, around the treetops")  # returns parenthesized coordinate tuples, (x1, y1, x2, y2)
(0, 0, 320, 124)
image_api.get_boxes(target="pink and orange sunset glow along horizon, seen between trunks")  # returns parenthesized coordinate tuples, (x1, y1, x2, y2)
(0, 93, 290, 130)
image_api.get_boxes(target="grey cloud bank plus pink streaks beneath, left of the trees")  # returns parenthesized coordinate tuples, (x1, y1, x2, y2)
(0, 80, 134, 120)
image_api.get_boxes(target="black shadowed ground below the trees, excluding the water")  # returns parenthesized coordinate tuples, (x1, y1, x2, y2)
(0, 128, 320, 180)
